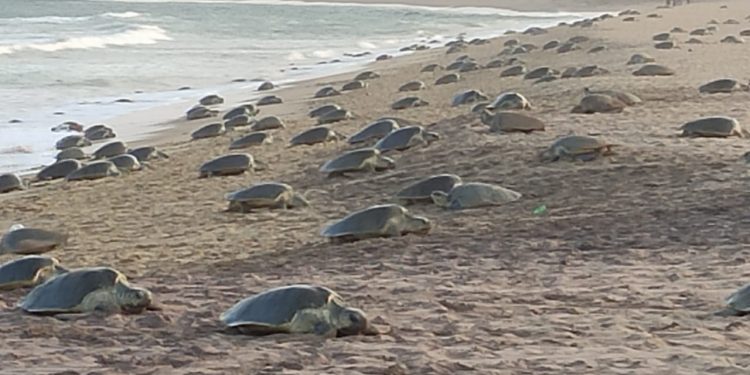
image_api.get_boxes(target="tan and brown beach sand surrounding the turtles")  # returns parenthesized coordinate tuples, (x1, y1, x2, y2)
(0, 1, 750, 374)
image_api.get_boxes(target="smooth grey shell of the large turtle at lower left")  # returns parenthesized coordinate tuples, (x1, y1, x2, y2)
(18, 267, 127, 313)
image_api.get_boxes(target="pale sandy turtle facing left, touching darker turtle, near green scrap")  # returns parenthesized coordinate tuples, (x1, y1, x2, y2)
(430, 182, 521, 210)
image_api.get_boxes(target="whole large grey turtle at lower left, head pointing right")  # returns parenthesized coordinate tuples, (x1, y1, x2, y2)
(18, 267, 153, 317)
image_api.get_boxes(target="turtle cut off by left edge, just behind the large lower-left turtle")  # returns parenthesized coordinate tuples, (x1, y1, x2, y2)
(0, 255, 68, 290)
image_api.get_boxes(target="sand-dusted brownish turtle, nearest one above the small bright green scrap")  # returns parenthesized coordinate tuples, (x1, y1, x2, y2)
(539, 135, 615, 161)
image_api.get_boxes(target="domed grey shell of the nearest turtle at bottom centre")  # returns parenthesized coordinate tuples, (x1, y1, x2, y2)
(219, 284, 341, 334)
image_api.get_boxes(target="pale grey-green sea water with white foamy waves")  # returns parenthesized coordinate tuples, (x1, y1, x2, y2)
(0, 0, 591, 173)
